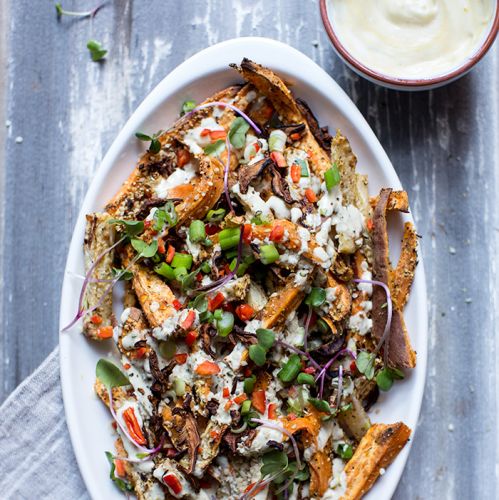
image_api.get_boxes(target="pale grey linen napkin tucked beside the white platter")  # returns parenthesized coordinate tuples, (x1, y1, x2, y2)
(0, 348, 89, 500)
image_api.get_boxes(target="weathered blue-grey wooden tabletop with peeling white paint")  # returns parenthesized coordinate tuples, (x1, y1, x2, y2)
(0, 0, 499, 500)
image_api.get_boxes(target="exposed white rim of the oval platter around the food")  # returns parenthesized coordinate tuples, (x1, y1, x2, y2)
(59, 37, 428, 500)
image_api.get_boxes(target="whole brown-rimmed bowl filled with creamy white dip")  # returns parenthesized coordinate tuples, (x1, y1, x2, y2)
(320, 0, 499, 90)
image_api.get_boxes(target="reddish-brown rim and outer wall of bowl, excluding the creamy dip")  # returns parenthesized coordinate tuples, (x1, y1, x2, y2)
(320, 0, 499, 90)
